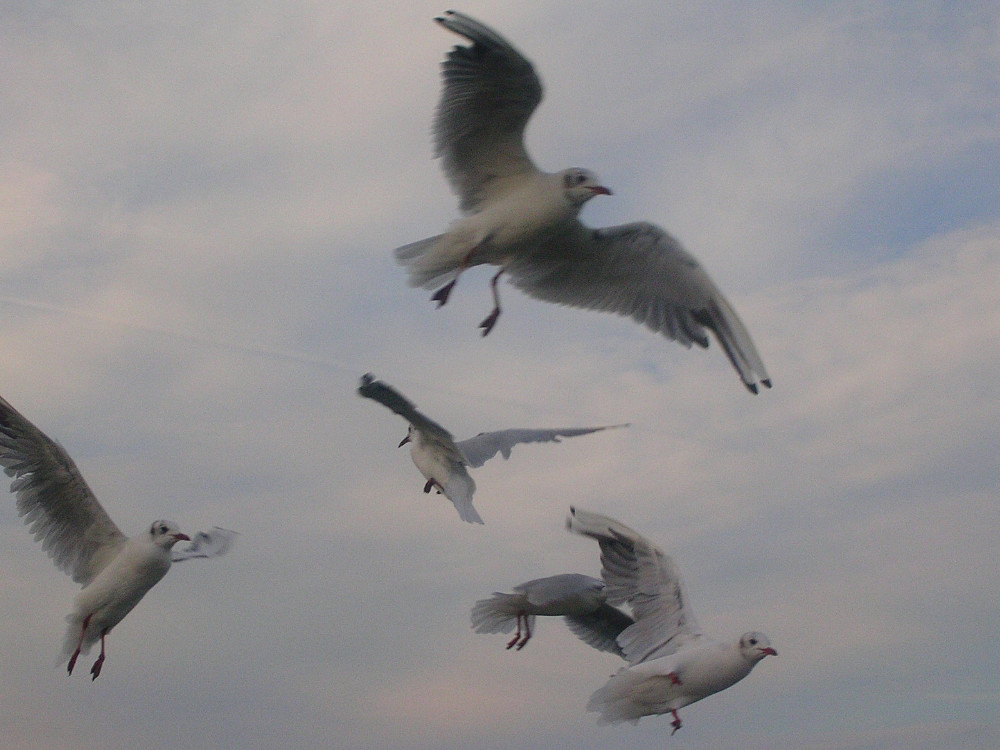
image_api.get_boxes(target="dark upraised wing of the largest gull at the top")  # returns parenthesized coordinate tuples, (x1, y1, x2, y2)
(434, 11, 542, 212)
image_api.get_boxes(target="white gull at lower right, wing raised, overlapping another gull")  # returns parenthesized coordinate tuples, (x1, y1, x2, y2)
(566, 508, 778, 734)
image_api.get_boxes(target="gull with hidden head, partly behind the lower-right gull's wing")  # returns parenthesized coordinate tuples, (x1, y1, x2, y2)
(472, 573, 633, 656)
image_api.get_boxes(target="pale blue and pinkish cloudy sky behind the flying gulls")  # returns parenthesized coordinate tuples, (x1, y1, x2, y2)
(0, 0, 1000, 750)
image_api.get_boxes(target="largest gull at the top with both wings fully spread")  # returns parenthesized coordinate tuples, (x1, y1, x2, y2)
(395, 11, 771, 393)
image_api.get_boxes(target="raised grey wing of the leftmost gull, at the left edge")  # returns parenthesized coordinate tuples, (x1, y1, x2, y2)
(0, 398, 127, 586)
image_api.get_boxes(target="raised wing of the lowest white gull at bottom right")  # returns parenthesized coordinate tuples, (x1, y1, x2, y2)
(566, 508, 702, 664)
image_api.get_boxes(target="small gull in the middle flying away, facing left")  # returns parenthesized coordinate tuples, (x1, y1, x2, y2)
(358, 373, 628, 523)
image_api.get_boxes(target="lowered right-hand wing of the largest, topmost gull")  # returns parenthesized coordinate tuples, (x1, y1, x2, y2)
(505, 222, 771, 393)
